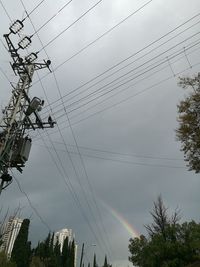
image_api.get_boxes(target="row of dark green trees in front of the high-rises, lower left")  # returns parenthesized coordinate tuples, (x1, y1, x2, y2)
(0, 219, 75, 267)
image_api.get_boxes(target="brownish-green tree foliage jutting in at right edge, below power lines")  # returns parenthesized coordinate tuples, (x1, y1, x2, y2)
(176, 74, 200, 173)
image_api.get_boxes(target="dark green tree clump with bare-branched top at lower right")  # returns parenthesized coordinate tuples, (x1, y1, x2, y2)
(129, 197, 200, 267)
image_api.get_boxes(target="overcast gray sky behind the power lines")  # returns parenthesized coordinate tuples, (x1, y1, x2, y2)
(0, 0, 200, 266)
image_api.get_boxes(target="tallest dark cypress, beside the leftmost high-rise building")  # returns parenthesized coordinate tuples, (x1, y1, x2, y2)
(11, 219, 31, 267)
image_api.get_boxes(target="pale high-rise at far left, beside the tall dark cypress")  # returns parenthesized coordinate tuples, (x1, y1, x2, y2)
(0, 217, 23, 258)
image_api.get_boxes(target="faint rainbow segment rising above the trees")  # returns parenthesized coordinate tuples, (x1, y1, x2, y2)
(103, 202, 140, 237)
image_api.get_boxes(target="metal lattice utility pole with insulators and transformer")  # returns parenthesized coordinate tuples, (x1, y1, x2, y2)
(0, 20, 55, 194)
